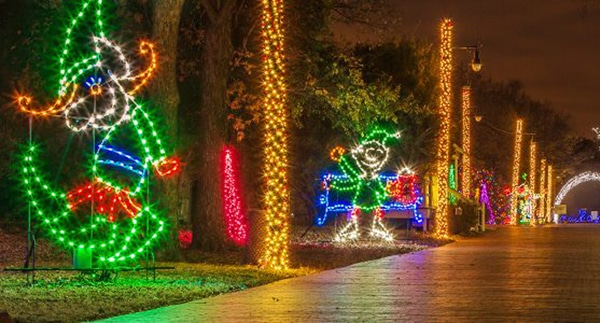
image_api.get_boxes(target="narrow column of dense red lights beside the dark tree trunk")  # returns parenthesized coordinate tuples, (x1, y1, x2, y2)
(221, 146, 248, 246)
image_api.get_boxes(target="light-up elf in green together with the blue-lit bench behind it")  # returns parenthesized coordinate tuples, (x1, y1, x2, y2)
(317, 127, 412, 242)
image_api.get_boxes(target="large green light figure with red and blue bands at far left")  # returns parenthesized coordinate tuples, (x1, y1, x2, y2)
(17, 0, 180, 267)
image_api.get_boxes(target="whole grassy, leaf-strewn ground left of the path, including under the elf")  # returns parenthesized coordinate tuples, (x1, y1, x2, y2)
(0, 228, 447, 322)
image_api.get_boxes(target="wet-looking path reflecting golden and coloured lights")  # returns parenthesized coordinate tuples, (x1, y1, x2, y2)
(98, 225, 600, 323)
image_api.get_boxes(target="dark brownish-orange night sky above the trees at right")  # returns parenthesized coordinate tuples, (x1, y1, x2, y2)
(336, 0, 600, 137)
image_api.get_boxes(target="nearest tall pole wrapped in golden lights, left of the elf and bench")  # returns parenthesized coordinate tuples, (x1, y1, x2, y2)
(260, 0, 291, 270)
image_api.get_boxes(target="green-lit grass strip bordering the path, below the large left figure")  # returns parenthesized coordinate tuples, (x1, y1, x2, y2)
(0, 263, 309, 322)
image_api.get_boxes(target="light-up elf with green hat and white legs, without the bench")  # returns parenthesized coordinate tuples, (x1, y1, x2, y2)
(322, 127, 400, 242)
